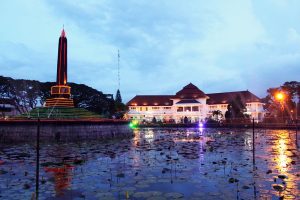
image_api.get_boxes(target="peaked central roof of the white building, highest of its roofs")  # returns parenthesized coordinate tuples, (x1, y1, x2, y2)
(175, 83, 207, 99)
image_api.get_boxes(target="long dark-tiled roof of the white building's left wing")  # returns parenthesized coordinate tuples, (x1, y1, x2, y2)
(127, 95, 174, 106)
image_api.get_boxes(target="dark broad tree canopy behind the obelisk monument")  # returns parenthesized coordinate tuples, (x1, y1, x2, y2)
(0, 76, 116, 117)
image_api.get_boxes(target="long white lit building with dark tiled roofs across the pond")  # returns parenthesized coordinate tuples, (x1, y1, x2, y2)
(127, 83, 265, 123)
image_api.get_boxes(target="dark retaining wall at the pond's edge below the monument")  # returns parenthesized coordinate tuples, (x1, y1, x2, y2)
(0, 123, 133, 142)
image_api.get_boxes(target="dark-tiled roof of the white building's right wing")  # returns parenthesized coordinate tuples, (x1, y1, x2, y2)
(206, 91, 261, 104)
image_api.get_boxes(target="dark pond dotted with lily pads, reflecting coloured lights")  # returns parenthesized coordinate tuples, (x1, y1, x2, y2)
(0, 128, 300, 199)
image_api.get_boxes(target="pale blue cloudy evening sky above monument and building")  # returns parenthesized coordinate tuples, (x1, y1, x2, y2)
(0, 0, 300, 102)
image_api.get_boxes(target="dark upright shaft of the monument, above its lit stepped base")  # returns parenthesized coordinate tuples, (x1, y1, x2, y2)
(56, 28, 68, 85)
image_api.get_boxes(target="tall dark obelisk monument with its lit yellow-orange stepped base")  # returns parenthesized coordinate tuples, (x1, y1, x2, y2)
(45, 29, 74, 108)
